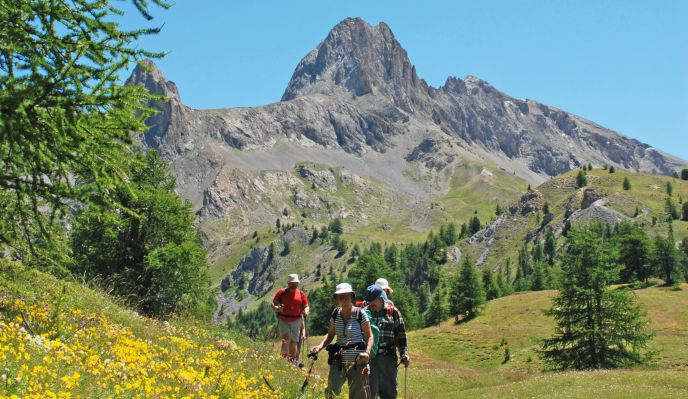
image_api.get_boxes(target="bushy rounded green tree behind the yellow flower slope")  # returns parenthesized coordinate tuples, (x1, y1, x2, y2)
(72, 151, 209, 316)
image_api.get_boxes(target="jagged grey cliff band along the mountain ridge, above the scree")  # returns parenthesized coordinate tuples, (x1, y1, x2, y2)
(130, 18, 683, 180)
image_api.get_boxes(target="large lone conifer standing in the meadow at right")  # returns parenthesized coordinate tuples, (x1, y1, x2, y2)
(541, 226, 651, 369)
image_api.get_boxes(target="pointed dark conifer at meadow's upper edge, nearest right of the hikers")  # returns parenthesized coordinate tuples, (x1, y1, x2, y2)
(449, 256, 485, 320)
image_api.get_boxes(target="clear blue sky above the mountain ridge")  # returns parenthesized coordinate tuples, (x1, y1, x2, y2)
(124, 0, 688, 159)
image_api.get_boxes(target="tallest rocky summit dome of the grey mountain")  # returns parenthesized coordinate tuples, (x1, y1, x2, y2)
(282, 18, 428, 109)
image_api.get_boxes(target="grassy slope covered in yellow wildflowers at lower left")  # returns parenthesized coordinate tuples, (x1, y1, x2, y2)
(0, 259, 323, 399)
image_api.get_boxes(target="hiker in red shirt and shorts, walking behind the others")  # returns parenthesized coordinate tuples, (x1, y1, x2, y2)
(272, 274, 310, 367)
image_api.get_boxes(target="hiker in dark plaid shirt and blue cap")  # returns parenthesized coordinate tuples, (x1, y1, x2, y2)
(365, 279, 410, 399)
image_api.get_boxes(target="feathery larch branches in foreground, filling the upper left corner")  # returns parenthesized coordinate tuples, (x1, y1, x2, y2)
(0, 0, 167, 260)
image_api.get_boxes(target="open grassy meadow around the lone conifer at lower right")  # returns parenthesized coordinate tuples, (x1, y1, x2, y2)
(400, 284, 688, 398)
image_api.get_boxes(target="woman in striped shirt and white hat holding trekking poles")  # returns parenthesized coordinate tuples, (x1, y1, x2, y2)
(311, 283, 373, 399)
